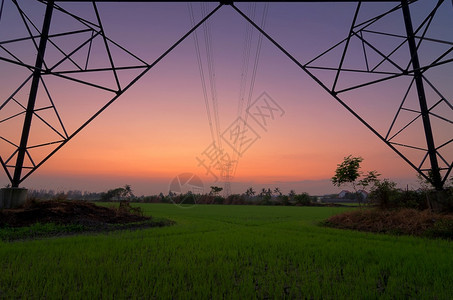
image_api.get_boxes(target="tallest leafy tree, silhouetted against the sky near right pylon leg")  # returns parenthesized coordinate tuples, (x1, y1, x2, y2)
(332, 155, 380, 206)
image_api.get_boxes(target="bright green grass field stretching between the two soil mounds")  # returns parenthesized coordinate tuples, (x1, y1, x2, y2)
(0, 204, 453, 299)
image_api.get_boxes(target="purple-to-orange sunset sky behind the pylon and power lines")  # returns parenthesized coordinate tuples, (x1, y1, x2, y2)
(0, 0, 453, 195)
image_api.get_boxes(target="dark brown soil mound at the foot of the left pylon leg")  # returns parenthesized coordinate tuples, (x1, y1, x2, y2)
(0, 200, 151, 227)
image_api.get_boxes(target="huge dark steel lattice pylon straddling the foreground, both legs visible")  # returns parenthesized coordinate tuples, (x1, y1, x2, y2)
(0, 0, 453, 189)
